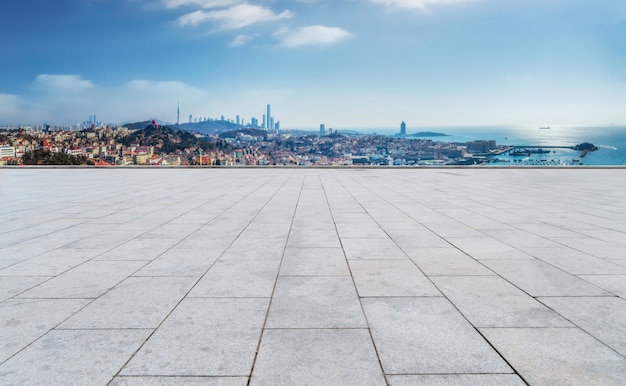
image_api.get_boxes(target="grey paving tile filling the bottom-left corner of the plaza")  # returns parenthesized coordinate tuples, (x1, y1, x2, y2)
(0, 330, 151, 385)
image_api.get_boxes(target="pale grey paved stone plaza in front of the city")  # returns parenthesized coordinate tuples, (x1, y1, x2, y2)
(0, 168, 626, 386)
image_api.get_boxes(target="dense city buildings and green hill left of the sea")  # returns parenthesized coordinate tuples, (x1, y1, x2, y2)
(0, 121, 496, 166)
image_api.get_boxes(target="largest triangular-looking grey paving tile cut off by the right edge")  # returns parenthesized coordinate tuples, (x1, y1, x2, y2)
(539, 297, 626, 357)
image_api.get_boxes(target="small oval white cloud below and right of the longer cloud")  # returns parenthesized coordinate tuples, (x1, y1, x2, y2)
(274, 25, 351, 48)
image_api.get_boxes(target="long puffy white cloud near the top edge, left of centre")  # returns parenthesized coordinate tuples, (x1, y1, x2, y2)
(178, 3, 293, 30)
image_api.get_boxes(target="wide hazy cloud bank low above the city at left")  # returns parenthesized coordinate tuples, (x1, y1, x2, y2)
(0, 74, 216, 124)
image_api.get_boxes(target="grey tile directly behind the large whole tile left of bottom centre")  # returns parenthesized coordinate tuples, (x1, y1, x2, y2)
(189, 259, 280, 298)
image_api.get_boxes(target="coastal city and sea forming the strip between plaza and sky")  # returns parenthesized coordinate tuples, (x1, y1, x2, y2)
(0, 121, 626, 166)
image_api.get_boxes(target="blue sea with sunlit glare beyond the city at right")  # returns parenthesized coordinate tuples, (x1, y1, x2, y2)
(360, 125, 626, 166)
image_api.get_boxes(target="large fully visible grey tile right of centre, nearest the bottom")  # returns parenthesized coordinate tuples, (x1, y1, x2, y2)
(362, 297, 512, 374)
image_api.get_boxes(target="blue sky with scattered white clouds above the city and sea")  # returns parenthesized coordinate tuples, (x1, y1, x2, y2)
(0, 0, 626, 129)
